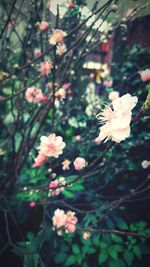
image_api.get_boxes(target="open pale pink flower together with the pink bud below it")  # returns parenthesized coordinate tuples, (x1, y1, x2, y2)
(33, 134, 66, 167)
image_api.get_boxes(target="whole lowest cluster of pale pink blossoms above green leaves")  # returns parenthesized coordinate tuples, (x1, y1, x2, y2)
(52, 209, 78, 235)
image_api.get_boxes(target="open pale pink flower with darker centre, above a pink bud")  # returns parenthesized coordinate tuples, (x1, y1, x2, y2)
(39, 134, 66, 158)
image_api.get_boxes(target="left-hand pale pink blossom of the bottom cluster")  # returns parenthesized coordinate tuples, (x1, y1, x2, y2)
(52, 209, 67, 229)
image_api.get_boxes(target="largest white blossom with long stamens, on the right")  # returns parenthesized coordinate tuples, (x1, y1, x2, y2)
(97, 94, 138, 143)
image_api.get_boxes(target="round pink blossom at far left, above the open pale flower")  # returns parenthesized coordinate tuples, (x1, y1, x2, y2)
(25, 87, 43, 103)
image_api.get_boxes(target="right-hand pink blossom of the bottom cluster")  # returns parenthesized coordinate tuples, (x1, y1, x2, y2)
(65, 211, 78, 233)
